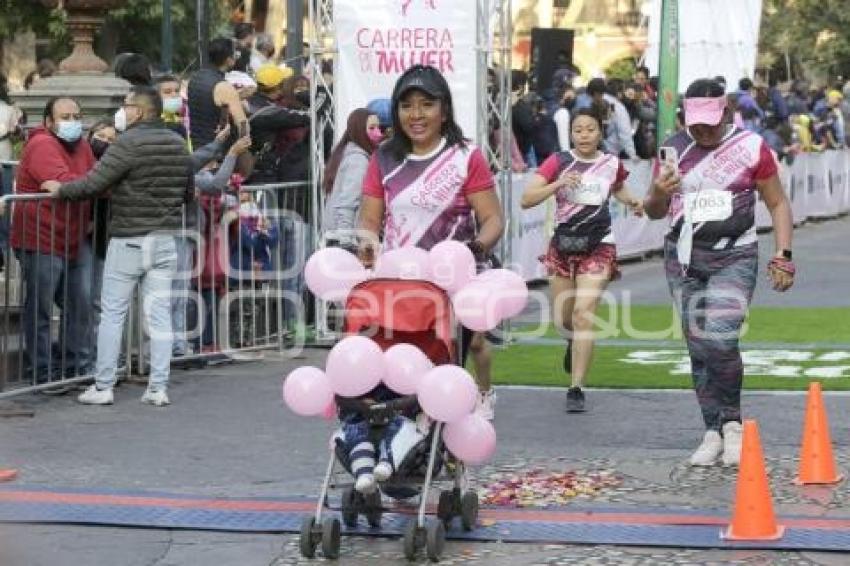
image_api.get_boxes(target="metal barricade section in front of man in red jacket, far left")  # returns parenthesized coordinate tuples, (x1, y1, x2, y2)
(0, 193, 109, 397)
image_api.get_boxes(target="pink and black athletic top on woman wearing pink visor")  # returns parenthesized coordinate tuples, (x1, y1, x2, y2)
(655, 126, 777, 250)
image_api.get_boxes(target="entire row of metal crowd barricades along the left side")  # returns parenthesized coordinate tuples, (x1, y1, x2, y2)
(0, 178, 315, 397)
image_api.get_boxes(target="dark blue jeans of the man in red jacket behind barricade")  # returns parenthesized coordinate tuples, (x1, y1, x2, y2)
(16, 241, 94, 383)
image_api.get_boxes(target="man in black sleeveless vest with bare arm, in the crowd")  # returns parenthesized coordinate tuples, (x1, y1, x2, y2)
(188, 37, 247, 151)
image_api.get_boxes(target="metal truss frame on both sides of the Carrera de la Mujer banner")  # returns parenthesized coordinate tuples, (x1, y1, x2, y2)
(306, 0, 515, 344)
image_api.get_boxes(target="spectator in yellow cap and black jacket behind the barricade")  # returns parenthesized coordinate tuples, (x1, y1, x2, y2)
(248, 64, 310, 183)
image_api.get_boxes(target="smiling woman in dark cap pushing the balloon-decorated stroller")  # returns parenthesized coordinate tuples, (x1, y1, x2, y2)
(359, 65, 504, 418)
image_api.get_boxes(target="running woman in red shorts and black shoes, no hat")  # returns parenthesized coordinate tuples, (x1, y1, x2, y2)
(522, 108, 643, 413)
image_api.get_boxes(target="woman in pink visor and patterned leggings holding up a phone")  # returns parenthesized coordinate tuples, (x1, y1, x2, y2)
(645, 79, 795, 466)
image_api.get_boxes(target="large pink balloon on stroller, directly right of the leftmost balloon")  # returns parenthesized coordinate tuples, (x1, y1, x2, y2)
(322, 336, 387, 400)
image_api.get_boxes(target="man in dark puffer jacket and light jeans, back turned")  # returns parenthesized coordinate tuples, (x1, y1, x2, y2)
(41, 86, 193, 407)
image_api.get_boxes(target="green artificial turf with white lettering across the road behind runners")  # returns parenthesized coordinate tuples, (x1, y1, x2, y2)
(476, 305, 850, 390)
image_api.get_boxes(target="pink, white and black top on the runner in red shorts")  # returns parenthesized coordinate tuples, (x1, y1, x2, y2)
(537, 151, 629, 244)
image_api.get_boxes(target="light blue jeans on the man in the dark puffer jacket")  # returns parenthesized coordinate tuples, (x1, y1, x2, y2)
(95, 235, 177, 390)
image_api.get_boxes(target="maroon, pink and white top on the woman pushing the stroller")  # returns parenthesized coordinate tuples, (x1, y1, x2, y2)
(363, 139, 495, 250)
